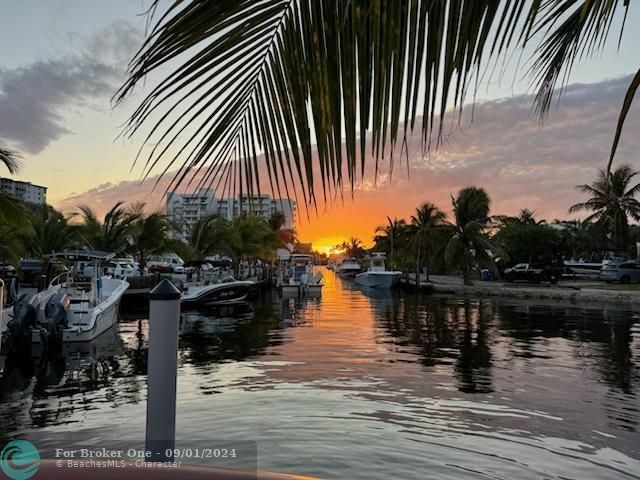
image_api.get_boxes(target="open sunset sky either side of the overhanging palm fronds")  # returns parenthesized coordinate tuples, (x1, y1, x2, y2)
(0, 0, 640, 253)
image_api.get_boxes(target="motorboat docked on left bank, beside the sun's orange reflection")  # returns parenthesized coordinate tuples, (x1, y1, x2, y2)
(278, 253, 323, 296)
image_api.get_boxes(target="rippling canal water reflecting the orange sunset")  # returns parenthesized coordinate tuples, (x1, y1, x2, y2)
(0, 272, 640, 480)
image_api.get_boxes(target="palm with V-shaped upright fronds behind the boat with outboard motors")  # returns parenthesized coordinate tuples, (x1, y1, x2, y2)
(78, 202, 139, 255)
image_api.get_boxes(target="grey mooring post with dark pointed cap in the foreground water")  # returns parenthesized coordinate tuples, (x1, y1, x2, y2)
(146, 278, 180, 461)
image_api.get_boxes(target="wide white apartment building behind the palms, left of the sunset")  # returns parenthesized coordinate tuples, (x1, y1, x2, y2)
(167, 189, 296, 241)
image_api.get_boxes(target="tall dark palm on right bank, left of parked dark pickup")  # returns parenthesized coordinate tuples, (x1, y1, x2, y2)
(445, 187, 499, 285)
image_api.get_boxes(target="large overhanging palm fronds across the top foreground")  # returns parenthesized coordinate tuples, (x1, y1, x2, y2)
(115, 0, 640, 205)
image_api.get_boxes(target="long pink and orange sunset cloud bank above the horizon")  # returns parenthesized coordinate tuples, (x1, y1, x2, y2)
(53, 77, 640, 244)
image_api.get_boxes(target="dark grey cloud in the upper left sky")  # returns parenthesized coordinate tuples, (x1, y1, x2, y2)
(0, 22, 142, 154)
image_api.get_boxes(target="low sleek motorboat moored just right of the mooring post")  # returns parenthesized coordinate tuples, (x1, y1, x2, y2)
(181, 276, 255, 307)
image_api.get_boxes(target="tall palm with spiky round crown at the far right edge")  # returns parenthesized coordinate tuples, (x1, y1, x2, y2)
(569, 165, 640, 252)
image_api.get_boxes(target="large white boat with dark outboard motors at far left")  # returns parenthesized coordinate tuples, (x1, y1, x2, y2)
(3, 250, 129, 344)
